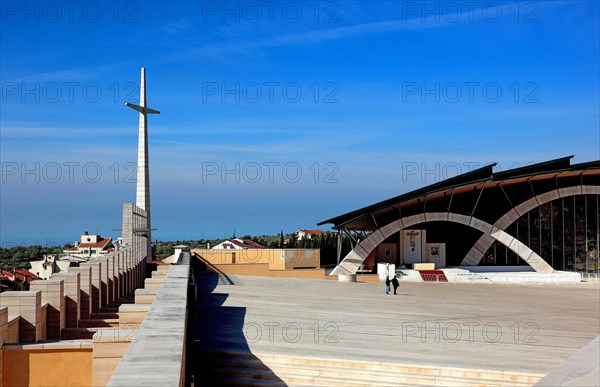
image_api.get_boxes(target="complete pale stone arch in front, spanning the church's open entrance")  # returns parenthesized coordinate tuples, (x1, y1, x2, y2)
(330, 212, 554, 275)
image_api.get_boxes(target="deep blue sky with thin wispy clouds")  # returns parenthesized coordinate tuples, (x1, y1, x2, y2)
(0, 1, 600, 247)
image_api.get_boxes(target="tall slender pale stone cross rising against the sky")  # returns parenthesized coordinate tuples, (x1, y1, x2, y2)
(125, 67, 160, 254)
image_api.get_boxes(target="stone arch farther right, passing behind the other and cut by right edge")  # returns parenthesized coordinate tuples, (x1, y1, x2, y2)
(461, 185, 600, 266)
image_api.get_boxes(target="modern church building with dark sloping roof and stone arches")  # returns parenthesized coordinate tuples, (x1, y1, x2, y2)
(319, 156, 600, 274)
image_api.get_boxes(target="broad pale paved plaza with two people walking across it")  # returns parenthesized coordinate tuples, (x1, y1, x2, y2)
(188, 274, 600, 373)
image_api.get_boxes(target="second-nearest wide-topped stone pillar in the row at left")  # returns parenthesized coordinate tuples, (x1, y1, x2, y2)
(29, 279, 67, 340)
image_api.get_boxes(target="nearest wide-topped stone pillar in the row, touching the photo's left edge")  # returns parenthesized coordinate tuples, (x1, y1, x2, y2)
(0, 291, 42, 343)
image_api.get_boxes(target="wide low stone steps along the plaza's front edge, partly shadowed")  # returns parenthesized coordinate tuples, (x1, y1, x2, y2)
(195, 351, 544, 387)
